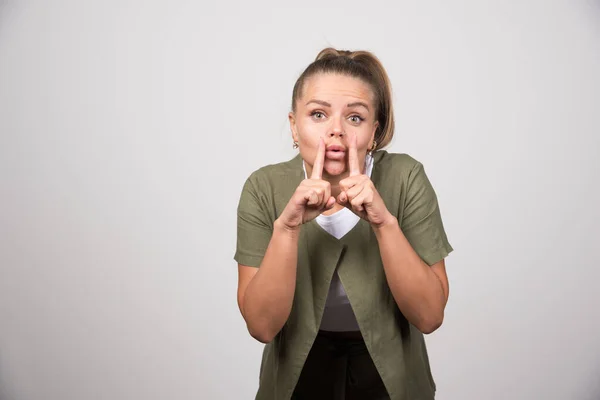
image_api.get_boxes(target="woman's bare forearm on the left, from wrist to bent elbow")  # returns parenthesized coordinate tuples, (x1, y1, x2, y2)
(242, 221, 300, 343)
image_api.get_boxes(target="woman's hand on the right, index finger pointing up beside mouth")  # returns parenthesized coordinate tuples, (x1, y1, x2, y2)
(336, 136, 396, 227)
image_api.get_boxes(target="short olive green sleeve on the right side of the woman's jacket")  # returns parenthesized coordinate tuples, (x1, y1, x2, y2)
(400, 161, 453, 265)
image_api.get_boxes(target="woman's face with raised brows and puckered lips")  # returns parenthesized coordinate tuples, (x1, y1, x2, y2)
(289, 74, 377, 179)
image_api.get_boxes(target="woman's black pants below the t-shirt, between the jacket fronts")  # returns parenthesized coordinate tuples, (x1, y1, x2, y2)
(292, 332, 390, 400)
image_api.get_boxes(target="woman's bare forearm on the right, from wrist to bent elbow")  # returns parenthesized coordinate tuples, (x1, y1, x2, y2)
(373, 218, 446, 333)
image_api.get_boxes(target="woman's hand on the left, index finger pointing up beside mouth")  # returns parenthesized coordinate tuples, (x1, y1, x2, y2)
(278, 138, 335, 229)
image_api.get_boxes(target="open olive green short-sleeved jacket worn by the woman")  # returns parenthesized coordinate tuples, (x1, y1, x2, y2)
(234, 151, 452, 400)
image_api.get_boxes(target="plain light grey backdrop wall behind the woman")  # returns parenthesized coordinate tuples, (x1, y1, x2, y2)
(0, 0, 600, 400)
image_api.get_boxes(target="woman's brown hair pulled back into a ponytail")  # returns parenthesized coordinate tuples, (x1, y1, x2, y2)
(292, 47, 394, 150)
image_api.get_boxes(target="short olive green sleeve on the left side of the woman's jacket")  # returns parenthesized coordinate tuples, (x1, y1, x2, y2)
(234, 174, 273, 267)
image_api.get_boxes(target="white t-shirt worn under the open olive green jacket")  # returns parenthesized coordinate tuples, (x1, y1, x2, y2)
(303, 154, 373, 332)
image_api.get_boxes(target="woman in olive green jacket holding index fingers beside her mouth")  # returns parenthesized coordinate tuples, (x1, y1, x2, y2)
(235, 48, 452, 400)
